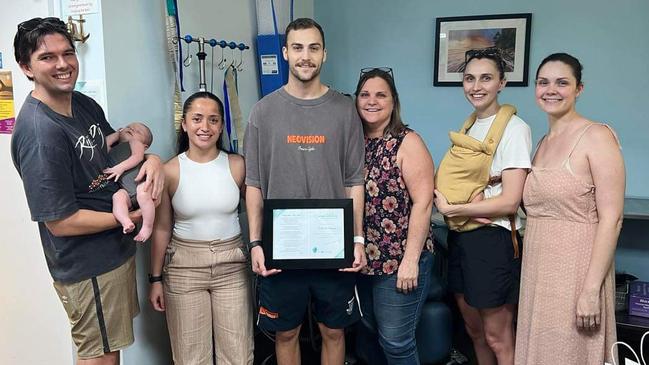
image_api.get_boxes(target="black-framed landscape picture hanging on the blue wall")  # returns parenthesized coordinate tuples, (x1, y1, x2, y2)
(433, 13, 532, 86)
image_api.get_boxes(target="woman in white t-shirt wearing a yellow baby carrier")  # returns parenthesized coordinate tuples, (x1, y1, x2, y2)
(435, 48, 532, 365)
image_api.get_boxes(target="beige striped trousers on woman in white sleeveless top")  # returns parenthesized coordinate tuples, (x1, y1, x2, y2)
(163, 236, 253, 365)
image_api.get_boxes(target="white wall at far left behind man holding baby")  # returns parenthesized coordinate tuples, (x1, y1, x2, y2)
(0, 0, 73, 365)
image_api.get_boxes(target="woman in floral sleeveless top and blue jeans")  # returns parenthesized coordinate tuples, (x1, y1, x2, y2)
(355, 68, 434, 364)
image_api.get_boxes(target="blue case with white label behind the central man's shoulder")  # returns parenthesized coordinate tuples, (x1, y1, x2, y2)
(257, 34, 288, 97)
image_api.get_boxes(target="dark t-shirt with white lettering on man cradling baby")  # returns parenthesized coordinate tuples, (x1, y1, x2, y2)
(11, 92, 135, 283)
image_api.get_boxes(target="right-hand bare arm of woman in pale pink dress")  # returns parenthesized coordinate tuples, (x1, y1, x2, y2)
(576, 126, 625, 328)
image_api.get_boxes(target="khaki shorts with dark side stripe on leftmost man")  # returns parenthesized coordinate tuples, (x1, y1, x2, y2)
(54, 256, 140, 359)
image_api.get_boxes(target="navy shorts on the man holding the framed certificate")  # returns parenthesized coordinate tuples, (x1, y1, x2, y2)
(257, 270, 360, 331)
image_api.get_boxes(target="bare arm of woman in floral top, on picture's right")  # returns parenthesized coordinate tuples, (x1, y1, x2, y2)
(397, 132, 435, 292)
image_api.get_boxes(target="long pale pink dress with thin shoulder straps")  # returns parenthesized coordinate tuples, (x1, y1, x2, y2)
(515, 124, 616, 365)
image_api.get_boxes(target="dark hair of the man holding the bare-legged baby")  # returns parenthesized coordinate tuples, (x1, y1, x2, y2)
(14, 17, 76, 81)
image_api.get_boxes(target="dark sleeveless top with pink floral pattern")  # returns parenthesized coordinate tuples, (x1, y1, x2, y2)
(363, 129, 433, 275)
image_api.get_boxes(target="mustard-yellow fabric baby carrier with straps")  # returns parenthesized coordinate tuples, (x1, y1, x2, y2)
(435, 104, 518, 257)
